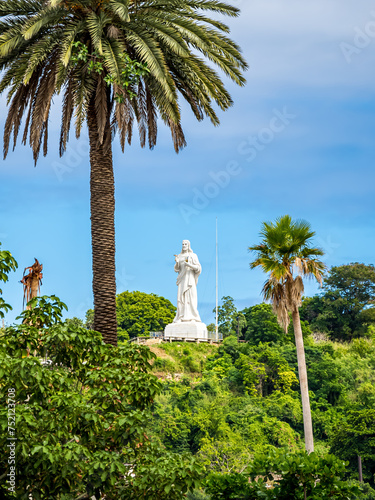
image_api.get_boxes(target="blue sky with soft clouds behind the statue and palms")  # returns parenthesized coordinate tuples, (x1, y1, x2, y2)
(0, 0, 375, 323)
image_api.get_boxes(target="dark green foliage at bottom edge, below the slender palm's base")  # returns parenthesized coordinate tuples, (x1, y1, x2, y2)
(205, 450, 366, 500)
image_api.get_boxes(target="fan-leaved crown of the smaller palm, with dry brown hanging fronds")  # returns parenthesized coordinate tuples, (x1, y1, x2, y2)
(249, 215, 326, 329)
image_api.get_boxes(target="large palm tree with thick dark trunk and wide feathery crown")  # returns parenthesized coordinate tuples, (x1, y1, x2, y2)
(0, 0, 246, 345)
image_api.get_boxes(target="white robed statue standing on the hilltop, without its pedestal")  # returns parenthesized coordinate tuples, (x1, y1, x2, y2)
(173, 240, 202, 323)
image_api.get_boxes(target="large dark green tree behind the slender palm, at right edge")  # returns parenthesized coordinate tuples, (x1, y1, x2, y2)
(301, 262, 375, 340)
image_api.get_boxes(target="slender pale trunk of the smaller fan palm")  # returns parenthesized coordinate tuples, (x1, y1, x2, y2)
(292, 308, 314, 453)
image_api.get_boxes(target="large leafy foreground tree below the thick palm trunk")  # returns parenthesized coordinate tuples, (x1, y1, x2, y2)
(0, 297, 202, 500)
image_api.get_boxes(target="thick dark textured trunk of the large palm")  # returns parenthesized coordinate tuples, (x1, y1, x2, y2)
(87, 100, 117, 346)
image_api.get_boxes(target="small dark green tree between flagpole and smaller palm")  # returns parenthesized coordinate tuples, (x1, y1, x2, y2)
(242, 303, 285, 344)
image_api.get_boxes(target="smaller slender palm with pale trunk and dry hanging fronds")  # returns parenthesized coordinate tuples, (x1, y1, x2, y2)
(249, 215, 326, 453)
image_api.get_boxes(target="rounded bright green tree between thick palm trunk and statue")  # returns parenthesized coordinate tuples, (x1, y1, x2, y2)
(116, 291, 176, 338)
